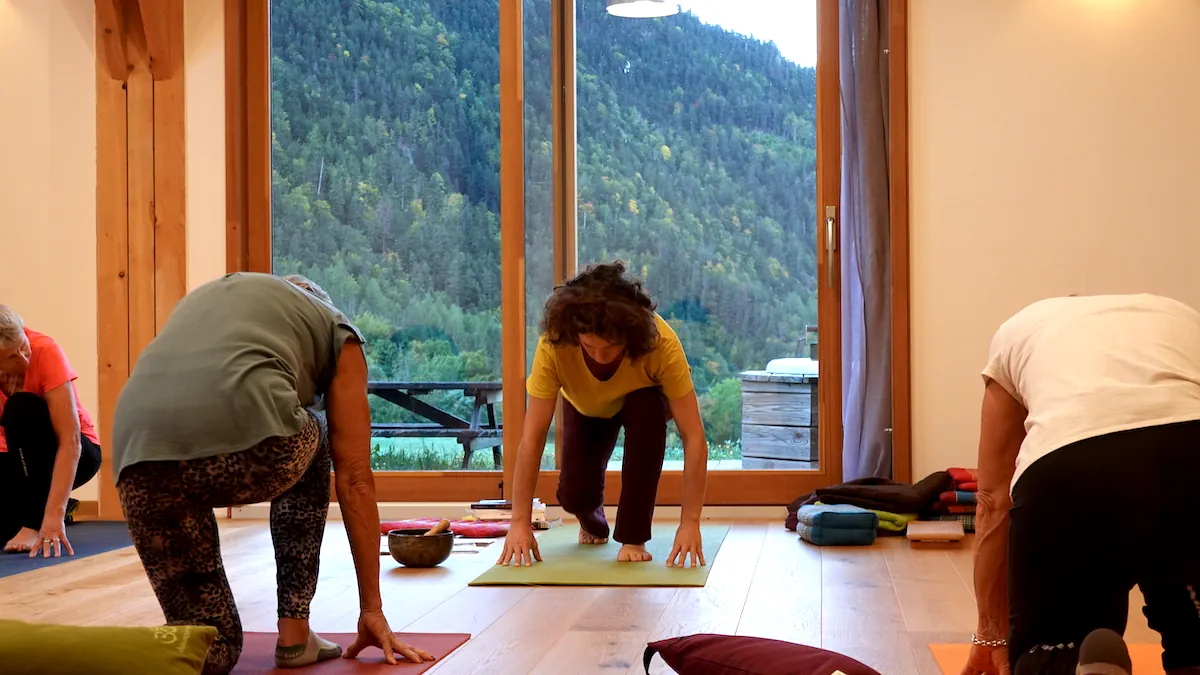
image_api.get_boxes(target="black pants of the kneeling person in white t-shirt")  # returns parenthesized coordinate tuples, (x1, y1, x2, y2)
(1008, 422, 1200, 675)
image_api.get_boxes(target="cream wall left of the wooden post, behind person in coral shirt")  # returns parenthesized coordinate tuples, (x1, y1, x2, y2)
(0, 0, 97, 500)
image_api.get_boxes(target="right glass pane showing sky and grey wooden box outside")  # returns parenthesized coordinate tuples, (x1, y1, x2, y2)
(576, 0, 820, 470)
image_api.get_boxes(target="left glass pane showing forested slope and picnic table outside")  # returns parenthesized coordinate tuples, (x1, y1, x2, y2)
(271, 0, 503, 471)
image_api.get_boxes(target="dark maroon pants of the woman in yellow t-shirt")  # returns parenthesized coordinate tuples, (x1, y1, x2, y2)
(558, 387, 671, 544)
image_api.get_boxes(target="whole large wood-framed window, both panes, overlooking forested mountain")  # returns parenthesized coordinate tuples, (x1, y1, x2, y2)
(241, 0, 864, 503)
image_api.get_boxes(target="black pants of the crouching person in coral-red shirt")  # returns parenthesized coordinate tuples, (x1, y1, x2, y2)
(0, 392, 100, 546)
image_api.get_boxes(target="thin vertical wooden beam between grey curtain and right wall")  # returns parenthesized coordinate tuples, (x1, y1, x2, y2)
(887, 0, 912, 483)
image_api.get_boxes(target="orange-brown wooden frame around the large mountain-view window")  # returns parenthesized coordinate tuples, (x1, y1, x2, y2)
(224, 0, 912, 506)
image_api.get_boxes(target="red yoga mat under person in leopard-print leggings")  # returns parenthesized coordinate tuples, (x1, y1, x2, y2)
(232, 633, 470, 675)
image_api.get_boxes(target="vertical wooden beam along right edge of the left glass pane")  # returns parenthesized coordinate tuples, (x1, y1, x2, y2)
(499, 0, 526, 498)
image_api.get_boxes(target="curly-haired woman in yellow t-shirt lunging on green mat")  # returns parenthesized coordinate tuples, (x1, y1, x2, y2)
(499, 262, 708, 566)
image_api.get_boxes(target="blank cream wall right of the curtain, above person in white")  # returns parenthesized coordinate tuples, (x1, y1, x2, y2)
(908, 0, 1200, 477)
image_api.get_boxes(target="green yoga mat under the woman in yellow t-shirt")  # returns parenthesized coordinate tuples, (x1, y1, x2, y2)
(469, 525, 730, 586)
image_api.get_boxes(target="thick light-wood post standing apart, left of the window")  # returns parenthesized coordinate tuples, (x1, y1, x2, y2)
(95, 0, 187, 520)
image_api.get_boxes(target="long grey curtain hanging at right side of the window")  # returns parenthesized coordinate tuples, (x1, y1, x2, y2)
(839, 0, 892, 480)
